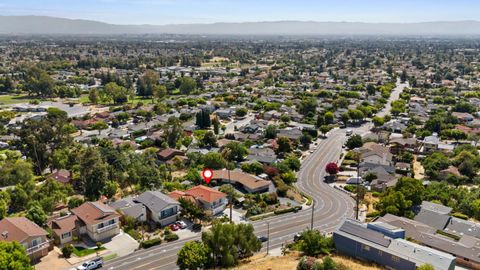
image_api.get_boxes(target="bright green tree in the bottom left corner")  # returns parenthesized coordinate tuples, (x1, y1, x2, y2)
(0, 241, 33, 270)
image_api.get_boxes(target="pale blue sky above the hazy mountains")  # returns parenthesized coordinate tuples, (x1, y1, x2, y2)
(0, 0, 480, 25)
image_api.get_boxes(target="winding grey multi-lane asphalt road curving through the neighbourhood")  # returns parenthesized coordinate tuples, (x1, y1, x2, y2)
(104, 82, 407, 270)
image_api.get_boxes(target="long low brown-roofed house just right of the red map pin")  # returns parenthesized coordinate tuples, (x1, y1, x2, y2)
(212, 170, 272, 193)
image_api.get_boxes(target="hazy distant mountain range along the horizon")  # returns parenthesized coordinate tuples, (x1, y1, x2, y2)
(0, 16, 480, 36)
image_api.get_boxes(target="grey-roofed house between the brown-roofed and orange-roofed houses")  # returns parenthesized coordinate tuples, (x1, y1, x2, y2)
(134, 191, 180, 226)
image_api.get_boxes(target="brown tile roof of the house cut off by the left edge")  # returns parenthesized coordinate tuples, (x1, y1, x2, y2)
(0, 217, 48, 243)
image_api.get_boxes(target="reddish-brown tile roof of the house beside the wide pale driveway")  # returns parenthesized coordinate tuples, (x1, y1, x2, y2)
(72, 202, 120, 225)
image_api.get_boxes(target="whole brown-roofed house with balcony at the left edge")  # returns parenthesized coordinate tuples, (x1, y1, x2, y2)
(0, 217, 53, 261)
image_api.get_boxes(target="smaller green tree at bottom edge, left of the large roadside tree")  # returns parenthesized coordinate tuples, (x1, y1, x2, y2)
(177, 241, 209, 270)
